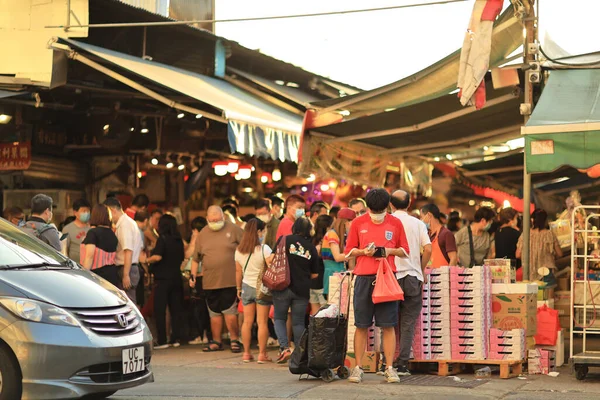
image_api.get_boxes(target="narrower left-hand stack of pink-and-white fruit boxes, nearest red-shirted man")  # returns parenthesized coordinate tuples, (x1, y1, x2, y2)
(420, 267, 452, 360)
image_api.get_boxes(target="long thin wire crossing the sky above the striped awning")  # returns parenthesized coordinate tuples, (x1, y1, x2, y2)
(45, 0, 469, 29)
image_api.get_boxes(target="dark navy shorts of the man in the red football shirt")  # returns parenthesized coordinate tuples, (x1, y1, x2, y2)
(354, 275, 398, 328)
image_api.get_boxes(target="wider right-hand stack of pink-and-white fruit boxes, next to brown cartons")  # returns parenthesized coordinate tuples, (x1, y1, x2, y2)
(449, 266, 492, 360)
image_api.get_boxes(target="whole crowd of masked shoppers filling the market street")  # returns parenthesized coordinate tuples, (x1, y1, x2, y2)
(3, 189, 562, 383)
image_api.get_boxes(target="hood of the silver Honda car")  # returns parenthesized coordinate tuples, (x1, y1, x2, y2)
(0, 269, 127, 308)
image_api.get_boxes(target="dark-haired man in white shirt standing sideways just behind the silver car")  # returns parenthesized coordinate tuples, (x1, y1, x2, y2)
(104, 197, 143, 303)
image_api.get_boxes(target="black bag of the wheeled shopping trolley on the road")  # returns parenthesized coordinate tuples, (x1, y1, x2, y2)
(308, 317, 348, 370)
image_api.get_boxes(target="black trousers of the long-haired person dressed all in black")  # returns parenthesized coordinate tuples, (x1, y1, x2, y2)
(154, 279, 183, 345)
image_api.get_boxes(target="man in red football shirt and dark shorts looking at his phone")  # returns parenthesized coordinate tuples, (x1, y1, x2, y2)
(345, 189, 409, 383)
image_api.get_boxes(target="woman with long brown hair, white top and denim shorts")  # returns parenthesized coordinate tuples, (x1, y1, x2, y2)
(235, 218, 273, 364)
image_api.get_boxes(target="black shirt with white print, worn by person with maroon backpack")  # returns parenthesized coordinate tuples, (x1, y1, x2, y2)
(285, 235, 320, 299)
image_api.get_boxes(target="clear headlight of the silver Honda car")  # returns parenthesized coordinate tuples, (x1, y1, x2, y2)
(0, 298, 80, 326)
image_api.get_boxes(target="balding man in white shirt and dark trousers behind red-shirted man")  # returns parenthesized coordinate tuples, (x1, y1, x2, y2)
(390, 190, 431, 375)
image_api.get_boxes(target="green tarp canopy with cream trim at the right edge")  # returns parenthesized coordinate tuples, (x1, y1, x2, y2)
(521, 69, 600, 174)
